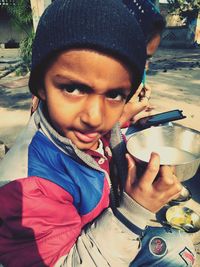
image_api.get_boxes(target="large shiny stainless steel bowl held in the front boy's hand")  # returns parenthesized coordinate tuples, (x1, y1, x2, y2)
(127, 124, 200, 181)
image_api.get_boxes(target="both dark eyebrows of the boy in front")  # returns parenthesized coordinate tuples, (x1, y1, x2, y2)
(55, 74, 131, 95)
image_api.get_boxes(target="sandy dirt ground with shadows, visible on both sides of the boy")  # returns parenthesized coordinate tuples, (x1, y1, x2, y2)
(0, 48, 200, 267)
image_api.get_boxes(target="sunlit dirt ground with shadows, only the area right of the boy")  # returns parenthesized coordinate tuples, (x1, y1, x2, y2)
(148, 49, 200, 131)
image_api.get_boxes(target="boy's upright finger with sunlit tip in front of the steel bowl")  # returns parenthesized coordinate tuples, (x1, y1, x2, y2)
(139, 152, 160, 184)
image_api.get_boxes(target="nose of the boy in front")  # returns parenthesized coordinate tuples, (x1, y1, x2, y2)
(81, 95, 104, 128)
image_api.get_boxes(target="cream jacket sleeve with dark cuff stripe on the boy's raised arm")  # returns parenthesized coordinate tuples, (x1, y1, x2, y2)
(55, 194, 154, 267)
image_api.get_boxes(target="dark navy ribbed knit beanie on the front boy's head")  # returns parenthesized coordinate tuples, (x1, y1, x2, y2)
(29, 0, 146, 99)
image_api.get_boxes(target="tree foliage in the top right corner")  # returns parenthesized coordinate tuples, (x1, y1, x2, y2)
(167, 0, 200, 25)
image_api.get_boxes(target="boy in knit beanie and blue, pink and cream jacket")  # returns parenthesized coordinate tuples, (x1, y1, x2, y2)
(0, 0, 195, 267)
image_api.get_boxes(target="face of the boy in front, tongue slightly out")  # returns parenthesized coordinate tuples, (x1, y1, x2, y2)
(39, 49, 131, 150)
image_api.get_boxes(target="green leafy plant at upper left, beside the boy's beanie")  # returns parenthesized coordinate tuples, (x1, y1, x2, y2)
(5, 0, 34, 71)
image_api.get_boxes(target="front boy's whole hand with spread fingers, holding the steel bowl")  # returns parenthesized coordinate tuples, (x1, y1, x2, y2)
(125, 153, 182, 212)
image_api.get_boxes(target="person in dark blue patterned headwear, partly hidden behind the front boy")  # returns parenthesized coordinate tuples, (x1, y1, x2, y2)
(120, 0, 165, 127)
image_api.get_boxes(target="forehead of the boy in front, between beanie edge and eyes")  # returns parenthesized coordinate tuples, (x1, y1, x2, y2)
(47, 49, 132, 93)
